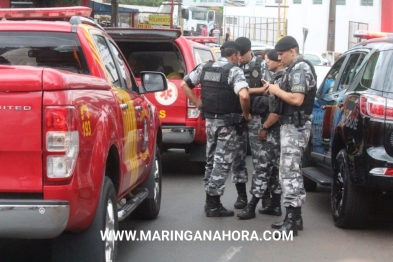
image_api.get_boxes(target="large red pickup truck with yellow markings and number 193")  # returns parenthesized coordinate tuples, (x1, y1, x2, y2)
(0, 7, 167, 261)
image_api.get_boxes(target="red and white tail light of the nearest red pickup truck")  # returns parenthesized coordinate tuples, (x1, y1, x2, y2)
(43, 106, 79, 184)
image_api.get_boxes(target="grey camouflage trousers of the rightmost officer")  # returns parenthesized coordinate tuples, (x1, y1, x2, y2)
(280, 121, 311, 207)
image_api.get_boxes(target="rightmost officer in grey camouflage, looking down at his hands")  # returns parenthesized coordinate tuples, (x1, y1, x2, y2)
(268, 36, 316, 236)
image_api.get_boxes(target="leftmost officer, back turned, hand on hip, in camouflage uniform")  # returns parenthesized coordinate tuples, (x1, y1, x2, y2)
(181, 41, 251, 217)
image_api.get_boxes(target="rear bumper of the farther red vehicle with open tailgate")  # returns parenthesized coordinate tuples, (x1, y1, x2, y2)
(162, 125, 195, 144)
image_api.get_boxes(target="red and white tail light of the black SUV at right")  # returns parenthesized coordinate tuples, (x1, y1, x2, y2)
(360, 95, 393, 120)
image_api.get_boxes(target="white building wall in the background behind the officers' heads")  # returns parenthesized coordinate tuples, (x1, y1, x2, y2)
(224, 0, 386, 53)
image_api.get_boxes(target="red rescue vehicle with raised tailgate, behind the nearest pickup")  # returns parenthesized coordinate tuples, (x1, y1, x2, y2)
(105, 28, 215, 161)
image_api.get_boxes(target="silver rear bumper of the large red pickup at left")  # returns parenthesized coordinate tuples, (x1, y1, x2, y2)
(0, 199, 70, 239)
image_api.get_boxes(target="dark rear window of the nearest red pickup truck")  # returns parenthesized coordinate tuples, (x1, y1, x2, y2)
(0, 32, 89, 74)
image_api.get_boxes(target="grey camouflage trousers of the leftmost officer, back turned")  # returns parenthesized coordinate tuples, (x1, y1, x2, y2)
(204, 118, 236, 196)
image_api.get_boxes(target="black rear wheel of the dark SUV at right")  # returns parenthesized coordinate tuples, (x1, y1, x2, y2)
(331, 149, 369, 228)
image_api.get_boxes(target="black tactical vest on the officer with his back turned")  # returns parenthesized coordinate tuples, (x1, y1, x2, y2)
(201, 61, 242, 114)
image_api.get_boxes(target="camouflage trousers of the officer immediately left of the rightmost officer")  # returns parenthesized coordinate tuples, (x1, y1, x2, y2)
(248, 115, 281, 198)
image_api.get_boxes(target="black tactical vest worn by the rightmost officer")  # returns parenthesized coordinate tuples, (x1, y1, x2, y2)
(281, 57, 317, 115)
